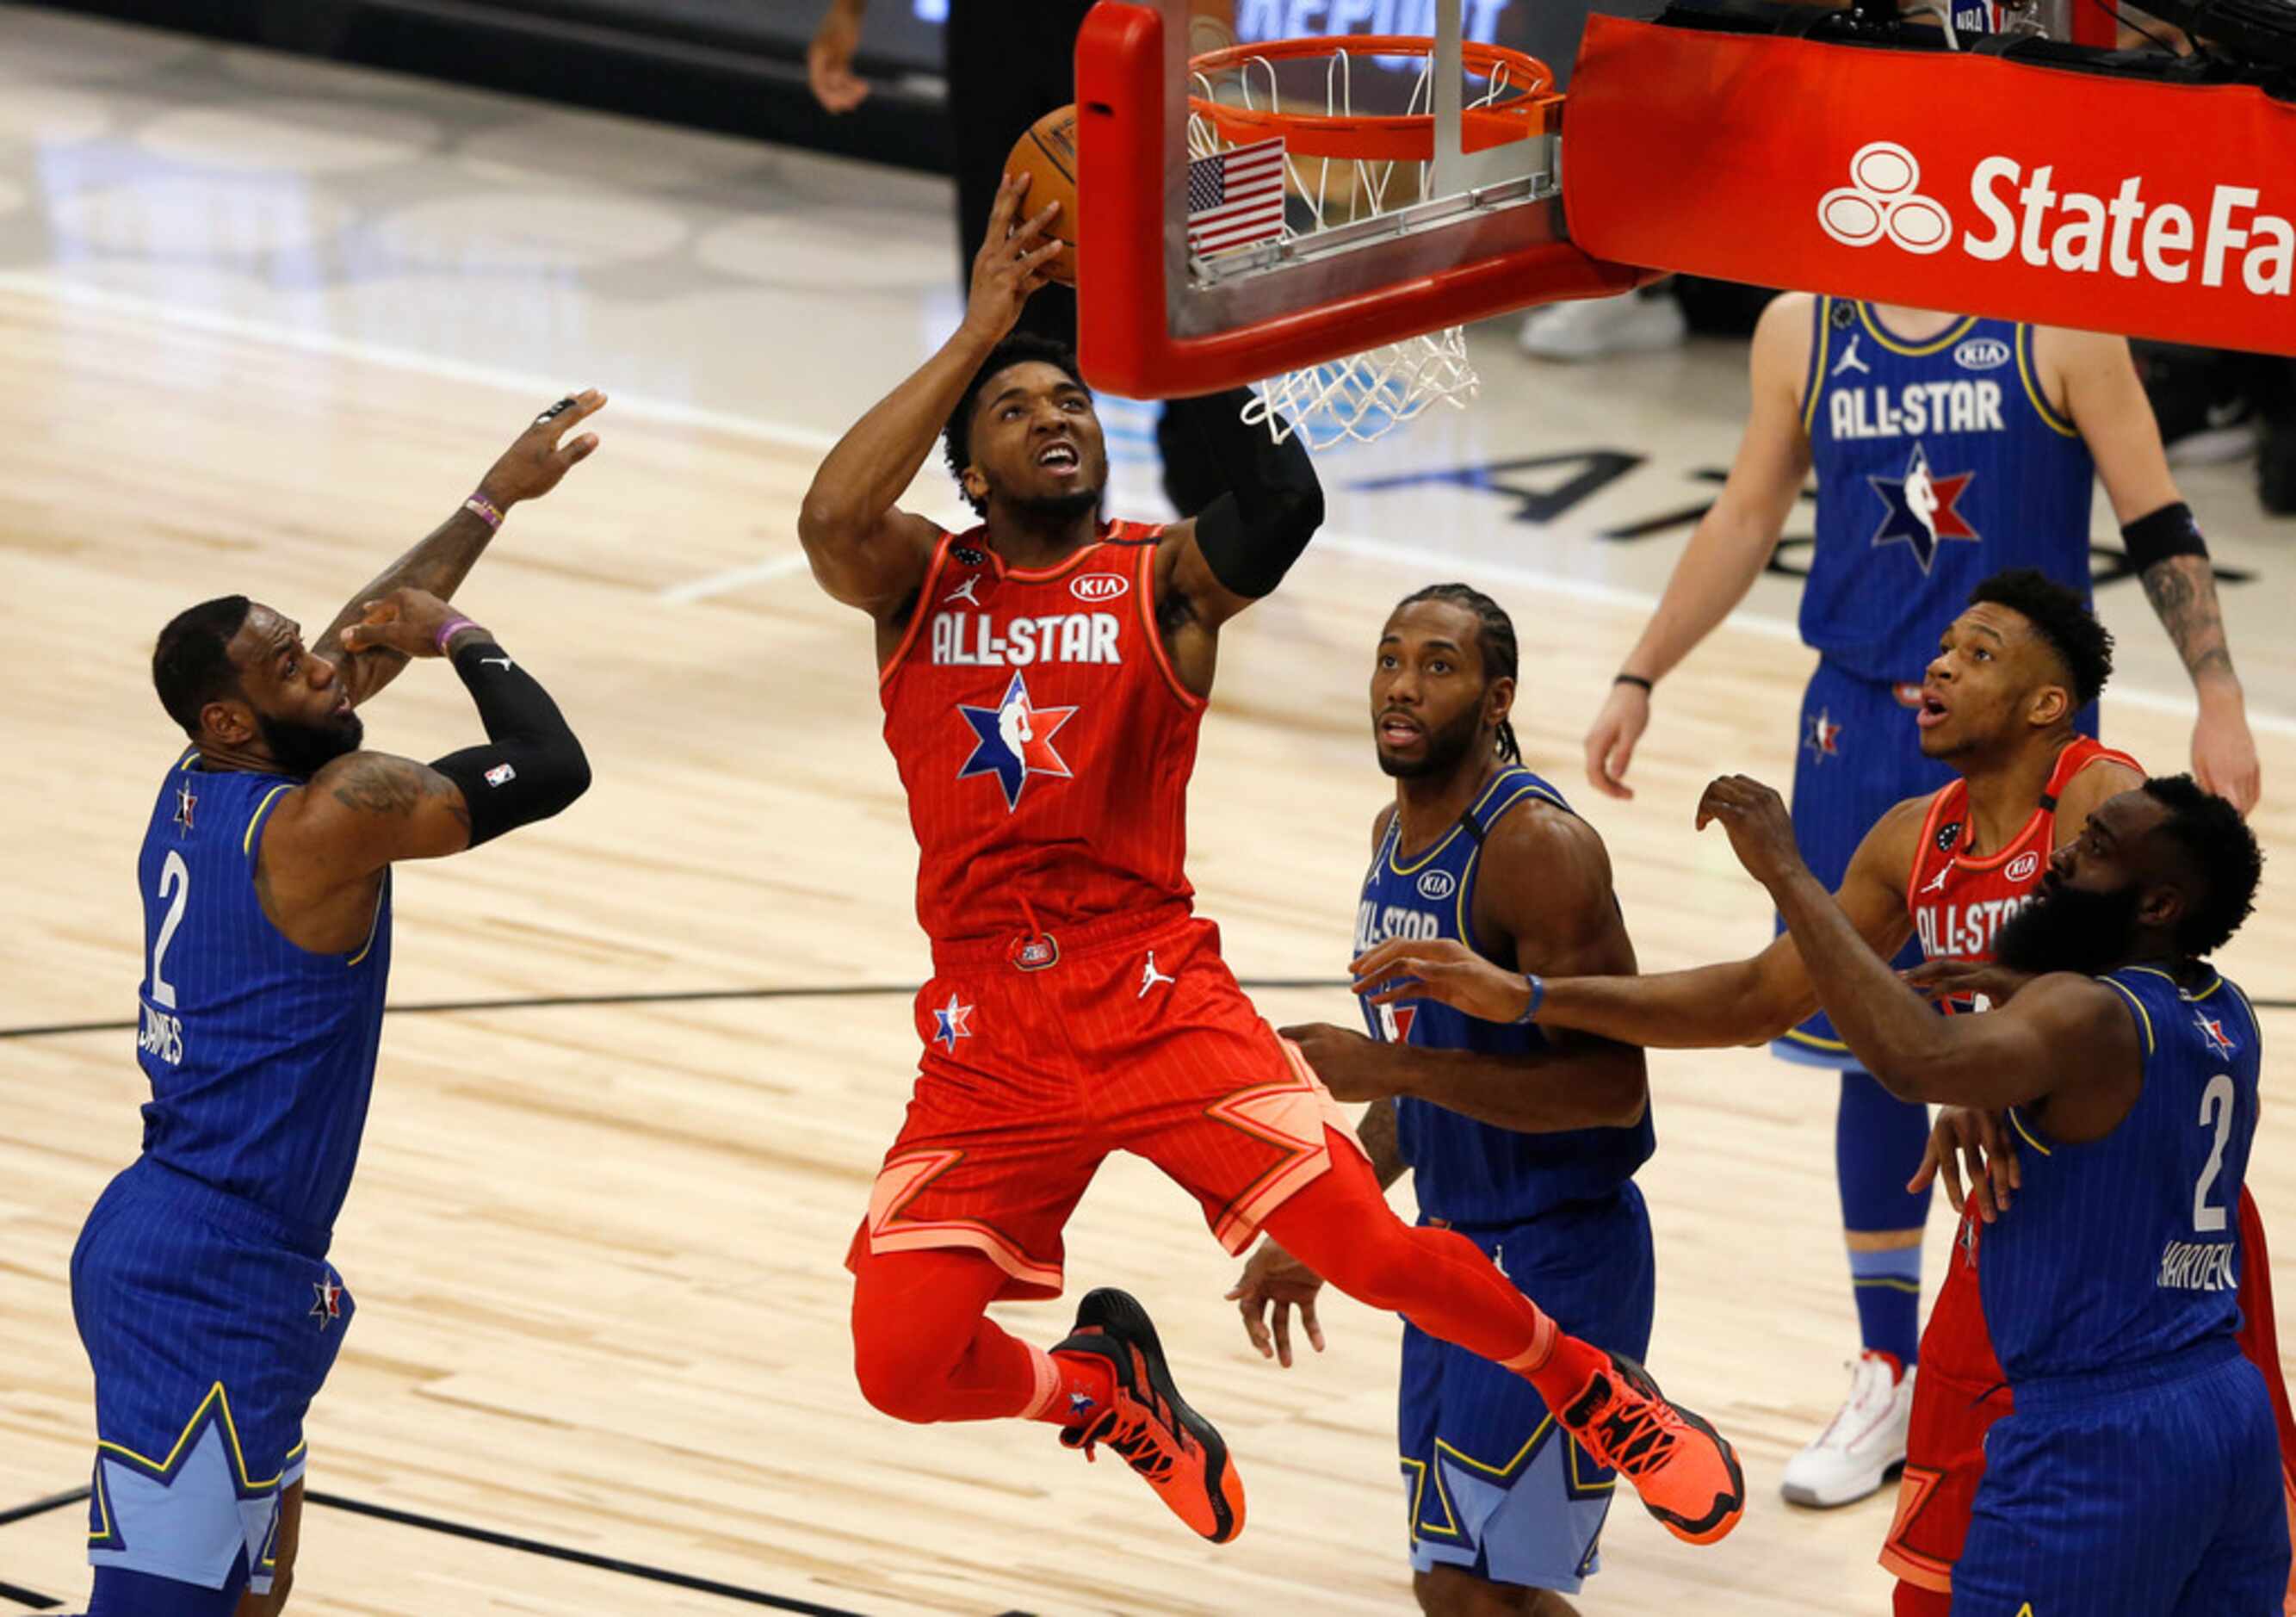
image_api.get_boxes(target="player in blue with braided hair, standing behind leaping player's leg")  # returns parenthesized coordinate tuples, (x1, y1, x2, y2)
(1228, 584, 1653, 1617)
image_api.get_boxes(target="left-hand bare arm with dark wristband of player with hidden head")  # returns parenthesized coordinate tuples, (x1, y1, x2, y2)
(1587, 292, 1810, 797)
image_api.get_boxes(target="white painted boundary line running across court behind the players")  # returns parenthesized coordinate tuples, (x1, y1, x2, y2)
(0, 269, 2296, 737)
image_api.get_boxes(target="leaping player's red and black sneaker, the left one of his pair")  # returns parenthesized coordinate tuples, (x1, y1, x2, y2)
(1054, 1286, 1245, 1544)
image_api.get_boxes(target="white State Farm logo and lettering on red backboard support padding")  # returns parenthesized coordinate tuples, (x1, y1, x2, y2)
(1818, 140, 2296, 296)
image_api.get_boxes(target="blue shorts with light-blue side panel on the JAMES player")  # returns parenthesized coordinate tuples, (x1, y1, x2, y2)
(71, 1157, 351, 1594)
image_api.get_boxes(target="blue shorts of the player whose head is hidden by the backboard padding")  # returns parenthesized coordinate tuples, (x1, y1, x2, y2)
(1770, 647, 2096, 1068)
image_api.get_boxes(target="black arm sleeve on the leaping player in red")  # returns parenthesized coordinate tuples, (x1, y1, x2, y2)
(1164, 388, 1322, 599)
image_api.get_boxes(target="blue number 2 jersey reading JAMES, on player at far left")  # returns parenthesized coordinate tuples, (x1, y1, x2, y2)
(135, 753, 390, 1231)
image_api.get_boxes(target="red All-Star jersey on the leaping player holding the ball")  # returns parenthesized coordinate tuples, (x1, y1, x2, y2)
(877, 522, 1204, 944)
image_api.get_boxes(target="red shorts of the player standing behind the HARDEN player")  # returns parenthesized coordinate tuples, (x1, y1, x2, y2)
(1880, 1187, 2296, 1617)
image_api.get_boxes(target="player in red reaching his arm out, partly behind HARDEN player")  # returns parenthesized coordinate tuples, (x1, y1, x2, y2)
(1357, 572, 2285, 1617)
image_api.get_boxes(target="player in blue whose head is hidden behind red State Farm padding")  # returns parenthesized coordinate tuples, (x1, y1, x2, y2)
(1587, 294, 2257, 1504)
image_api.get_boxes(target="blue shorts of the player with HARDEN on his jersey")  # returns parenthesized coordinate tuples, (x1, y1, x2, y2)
(1954, 1341, 2289, 1617)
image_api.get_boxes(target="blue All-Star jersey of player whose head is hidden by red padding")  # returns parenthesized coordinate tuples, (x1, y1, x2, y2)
(1803, 299, 2096, 685)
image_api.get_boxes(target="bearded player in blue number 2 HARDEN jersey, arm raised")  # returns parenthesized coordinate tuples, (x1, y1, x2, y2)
(1699, 777, 2289, 1617)
